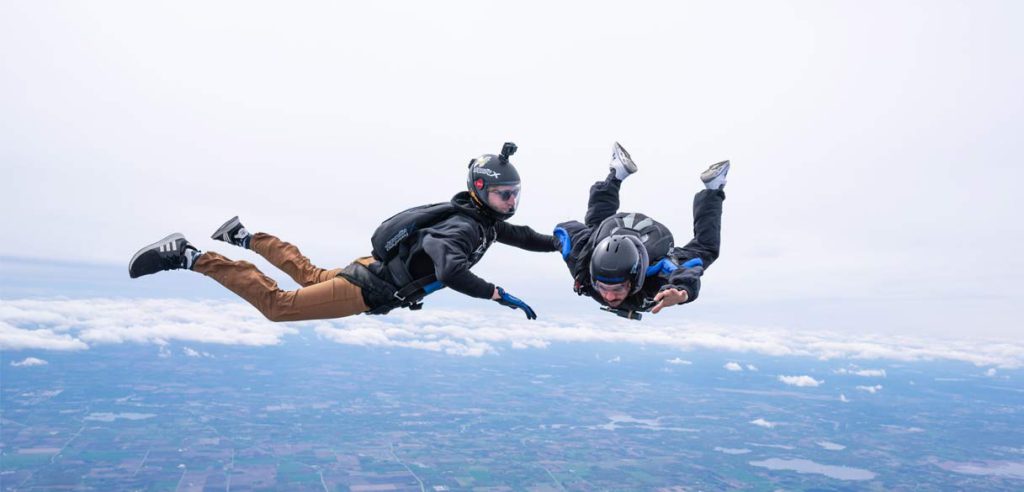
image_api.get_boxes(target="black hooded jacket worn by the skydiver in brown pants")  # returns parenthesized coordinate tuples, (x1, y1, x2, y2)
(384, 192, 558, 299)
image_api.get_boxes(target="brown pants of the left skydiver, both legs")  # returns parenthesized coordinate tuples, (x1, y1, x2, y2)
(193, 233, 375, 321)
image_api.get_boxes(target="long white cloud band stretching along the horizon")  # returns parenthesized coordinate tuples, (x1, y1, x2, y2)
(0, 298, 1024, 369)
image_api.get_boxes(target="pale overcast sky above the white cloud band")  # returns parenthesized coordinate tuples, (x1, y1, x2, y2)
(0, 1, 1024, 337)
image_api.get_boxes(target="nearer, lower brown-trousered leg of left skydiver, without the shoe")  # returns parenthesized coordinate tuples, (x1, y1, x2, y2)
(193, 251, 369, 321)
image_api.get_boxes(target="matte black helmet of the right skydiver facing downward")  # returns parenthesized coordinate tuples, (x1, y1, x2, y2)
(590, 236, 648, 295)
